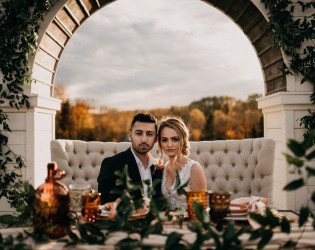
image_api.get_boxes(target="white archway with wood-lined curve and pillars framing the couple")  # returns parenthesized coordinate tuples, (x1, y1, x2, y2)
(0, 0, 314, 213)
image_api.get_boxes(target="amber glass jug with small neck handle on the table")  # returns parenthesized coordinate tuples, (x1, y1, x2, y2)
(34, 162, 70, 238)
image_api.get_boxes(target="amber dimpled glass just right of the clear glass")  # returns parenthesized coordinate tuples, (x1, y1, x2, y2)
(82, 192, 101, 223)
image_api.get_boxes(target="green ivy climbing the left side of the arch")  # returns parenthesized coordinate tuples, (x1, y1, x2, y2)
(0, 0, 51, 208)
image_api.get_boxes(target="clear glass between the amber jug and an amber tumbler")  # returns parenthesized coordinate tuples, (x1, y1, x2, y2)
(69, 184, 91, 213)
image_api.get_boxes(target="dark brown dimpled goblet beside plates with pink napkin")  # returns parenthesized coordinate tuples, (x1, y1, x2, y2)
(209, 191, 231, 231)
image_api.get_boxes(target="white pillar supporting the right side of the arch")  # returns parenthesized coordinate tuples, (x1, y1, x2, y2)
(257, 92, 315, 211)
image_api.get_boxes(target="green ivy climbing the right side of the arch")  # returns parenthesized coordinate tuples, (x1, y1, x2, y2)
(261, 0, 315, 144)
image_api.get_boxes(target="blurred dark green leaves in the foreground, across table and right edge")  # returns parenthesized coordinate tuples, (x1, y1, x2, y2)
(0, 131, 315, 250)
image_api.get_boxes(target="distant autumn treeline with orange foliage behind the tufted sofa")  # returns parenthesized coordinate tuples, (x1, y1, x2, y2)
(56, 84, 263, 142)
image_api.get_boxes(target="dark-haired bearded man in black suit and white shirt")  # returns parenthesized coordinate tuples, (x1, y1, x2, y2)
(97, 113, 162, 204)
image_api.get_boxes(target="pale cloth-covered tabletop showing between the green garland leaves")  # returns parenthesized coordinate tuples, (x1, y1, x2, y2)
(0, 211, 315, 250)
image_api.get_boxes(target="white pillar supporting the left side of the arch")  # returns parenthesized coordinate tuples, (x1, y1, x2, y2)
(0, 94, 61, 214)
